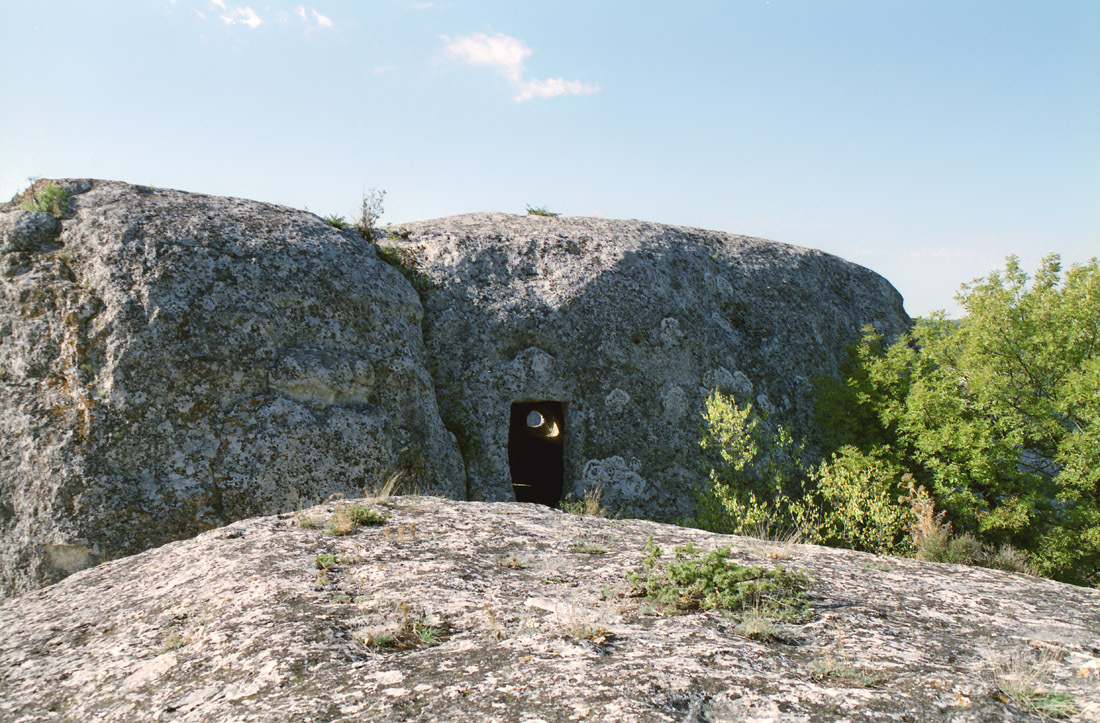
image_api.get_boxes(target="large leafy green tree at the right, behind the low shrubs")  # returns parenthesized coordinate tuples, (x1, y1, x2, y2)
(820, 255, 1100, 584)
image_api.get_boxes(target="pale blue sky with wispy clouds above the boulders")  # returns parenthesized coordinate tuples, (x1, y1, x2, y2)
(0, 0, 1100, 316)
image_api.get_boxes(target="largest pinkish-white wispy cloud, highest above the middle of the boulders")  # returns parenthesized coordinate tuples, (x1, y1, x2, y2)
(441, 33, 600, 103)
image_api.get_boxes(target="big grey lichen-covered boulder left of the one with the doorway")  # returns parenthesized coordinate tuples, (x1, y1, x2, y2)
(0, 180, 464, 595)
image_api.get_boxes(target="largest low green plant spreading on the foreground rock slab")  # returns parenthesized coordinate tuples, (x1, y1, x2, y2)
(627, 537, 810, 621)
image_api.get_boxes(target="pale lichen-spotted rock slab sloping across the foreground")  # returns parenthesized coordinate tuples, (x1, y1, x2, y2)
(0, 497, 1100, 723)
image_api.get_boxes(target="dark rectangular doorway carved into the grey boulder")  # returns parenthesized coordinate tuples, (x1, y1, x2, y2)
(508, 402, 565, 507)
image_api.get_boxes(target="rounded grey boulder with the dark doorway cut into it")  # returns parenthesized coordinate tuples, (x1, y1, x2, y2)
(384, 213, 910, 518)
